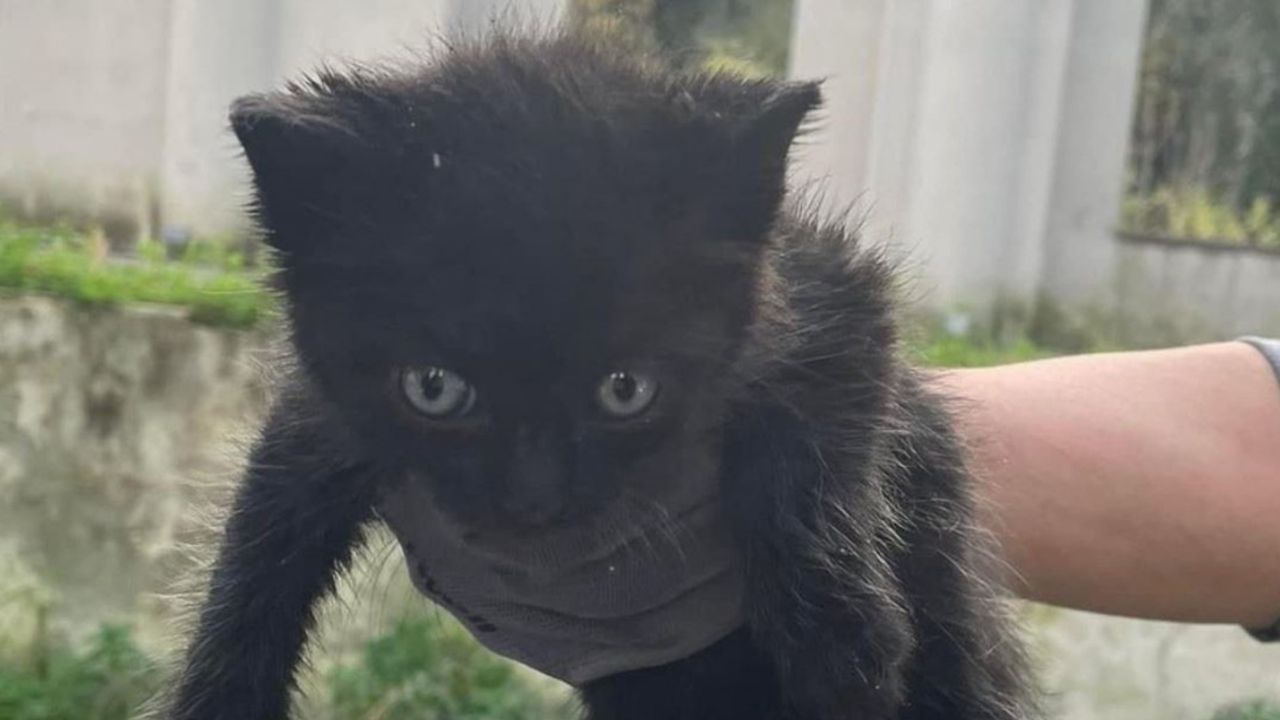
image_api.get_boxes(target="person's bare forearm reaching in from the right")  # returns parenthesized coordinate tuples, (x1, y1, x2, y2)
(936, 342, 1280, 628)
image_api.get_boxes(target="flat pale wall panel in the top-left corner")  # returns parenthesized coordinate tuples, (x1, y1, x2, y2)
(0, 0, 170, 240)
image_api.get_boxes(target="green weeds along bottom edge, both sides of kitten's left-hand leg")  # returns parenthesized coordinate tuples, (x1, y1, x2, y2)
(0, 615, 555, 720)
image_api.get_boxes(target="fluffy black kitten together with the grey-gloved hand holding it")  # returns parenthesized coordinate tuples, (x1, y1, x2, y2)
(170, 29, 1032, 720)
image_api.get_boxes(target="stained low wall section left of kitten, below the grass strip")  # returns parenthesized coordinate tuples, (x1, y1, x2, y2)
(0, 297, 265, 644)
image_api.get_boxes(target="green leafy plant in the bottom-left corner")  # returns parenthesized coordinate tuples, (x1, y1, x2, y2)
(0, 626, 159, 720)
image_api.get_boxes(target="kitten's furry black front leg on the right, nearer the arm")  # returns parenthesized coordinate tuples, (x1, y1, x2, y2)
(724, 410, 913, 720)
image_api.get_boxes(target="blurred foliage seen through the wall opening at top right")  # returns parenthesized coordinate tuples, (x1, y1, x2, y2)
(1129, 0, 1280, 229)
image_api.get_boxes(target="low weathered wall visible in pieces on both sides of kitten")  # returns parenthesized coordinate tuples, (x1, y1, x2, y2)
(0, 297, 1280, 720)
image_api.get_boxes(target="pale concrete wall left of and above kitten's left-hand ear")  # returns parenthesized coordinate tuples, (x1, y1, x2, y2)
(0, 0, 562, 237)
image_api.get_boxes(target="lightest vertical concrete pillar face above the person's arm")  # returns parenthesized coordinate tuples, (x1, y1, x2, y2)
(901, 0, 1053, 307)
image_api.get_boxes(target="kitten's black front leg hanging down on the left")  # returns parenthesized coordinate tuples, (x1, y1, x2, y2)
(166, 394, 374, 720)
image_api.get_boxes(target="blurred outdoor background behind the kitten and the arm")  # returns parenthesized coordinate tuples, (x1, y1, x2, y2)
(0, 0, 1280, 720)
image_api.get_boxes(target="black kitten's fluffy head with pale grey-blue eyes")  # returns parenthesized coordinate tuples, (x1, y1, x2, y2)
(232, 32, 818, 530)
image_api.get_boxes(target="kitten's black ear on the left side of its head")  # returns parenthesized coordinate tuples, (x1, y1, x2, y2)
(230, 92, 361, 250)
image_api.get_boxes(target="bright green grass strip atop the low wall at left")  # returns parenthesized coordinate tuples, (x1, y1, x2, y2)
(0, 220, 271, 328)
